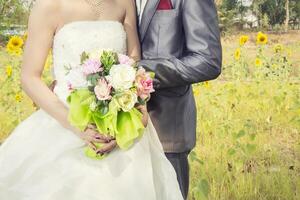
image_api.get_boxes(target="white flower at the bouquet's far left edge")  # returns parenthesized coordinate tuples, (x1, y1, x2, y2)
(66, 67, 88, 89)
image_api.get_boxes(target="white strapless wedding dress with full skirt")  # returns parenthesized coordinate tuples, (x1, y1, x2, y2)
(0, 21, 183, 200)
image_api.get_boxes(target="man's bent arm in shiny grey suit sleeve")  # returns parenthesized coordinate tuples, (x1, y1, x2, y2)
(139, 0, 222, 89)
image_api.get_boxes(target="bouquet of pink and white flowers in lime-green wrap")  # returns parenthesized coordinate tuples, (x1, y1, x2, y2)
(66, 50, 154, 159)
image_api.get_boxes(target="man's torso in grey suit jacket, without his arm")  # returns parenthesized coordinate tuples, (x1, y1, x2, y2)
(136, 0, 196, 152)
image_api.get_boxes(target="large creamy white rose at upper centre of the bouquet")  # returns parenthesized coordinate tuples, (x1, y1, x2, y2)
(108, 64, 136, 90)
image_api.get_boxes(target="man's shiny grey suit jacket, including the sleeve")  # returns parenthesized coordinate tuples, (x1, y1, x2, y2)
(139, 0, 222, 152)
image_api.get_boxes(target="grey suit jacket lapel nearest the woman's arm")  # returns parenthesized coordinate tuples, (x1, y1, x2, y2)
(139, 0, 160, 41)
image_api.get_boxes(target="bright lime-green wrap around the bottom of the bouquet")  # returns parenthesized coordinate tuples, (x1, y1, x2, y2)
(67, 89, 145, 159)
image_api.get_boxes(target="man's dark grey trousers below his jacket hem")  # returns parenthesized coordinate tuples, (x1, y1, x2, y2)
(165, 151, 190, 199)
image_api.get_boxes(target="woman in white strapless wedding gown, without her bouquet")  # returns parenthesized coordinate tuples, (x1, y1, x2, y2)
(0, 0, 183, 200)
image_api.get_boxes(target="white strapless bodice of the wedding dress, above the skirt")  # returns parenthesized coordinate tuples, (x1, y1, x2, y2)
(53, 21, 127, 104)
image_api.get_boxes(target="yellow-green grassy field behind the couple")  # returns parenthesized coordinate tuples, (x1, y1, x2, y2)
(0, 32, 300, 200)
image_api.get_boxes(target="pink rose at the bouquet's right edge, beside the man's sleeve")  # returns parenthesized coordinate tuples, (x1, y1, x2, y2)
(135, 68, 155, 100)
